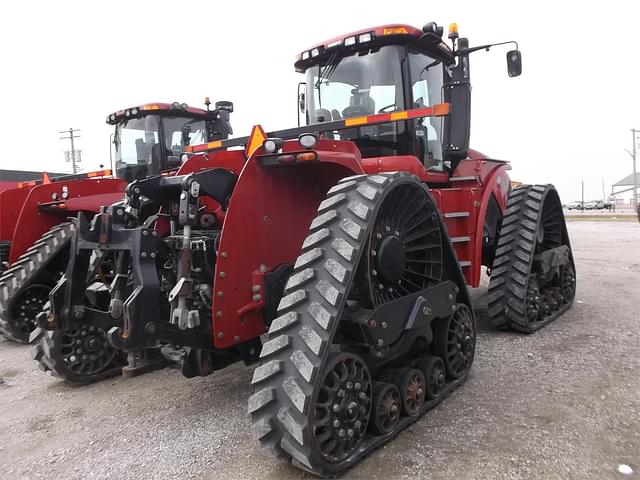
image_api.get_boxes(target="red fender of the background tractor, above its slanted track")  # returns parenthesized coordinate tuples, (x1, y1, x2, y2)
(8, 178, 126, 263)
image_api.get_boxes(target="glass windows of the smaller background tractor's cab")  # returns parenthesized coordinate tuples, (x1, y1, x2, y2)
(113, 115, 206, 182)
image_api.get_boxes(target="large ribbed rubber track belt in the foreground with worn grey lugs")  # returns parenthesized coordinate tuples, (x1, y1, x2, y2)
(248, 173, 459, 476)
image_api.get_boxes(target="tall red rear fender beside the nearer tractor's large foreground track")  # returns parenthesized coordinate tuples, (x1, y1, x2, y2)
(212, 140, 364, 349)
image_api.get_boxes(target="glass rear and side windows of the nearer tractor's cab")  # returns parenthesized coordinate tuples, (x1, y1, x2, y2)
(305, 45, 444, 172)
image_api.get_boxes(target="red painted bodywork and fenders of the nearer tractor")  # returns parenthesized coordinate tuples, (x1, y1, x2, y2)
(178, 104, 510, 349)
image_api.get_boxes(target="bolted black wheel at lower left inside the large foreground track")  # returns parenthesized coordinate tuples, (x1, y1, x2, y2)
(311, 352, 372, 463)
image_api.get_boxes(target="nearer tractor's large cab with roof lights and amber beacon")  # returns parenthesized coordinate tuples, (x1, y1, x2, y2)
(295, 23, 519, 177)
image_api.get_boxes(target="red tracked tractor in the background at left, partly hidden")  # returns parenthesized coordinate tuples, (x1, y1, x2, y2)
(0, 101, 232, 368)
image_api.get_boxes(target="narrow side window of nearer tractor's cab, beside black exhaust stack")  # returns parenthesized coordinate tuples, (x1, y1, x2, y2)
(409, 52, 444, 172)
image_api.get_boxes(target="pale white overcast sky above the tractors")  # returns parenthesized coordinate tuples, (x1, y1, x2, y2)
(0, 0, 640, 202)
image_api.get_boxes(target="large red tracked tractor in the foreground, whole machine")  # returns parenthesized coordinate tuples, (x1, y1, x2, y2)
(38, 23, 575, 476)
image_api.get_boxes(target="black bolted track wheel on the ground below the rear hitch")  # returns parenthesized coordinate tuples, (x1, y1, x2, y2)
(33, 325, 126, 384)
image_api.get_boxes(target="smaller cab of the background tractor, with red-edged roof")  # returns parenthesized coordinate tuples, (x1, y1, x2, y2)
(107, 99, 233, 182)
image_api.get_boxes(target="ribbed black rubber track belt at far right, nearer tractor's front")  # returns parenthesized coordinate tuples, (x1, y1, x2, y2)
(488, 185, 575, 333)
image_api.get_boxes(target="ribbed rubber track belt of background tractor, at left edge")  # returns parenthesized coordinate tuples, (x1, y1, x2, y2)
(0, 222, 76, 343)
